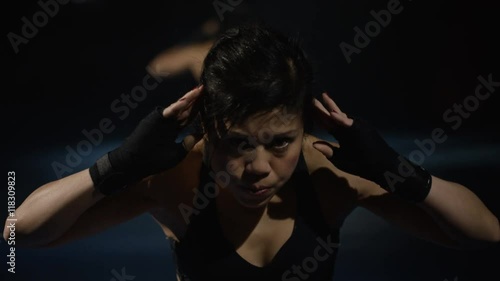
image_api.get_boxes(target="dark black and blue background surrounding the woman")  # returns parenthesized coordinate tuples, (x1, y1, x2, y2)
(0, 0, 500, 281)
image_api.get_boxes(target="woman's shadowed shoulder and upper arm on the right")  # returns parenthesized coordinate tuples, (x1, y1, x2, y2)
(303, 135, 458, 249)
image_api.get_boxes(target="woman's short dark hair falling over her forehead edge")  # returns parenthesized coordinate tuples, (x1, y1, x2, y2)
(191, 24, 313, 142)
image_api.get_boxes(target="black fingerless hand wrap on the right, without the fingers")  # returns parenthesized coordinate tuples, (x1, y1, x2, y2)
(322, 118, 432, 203)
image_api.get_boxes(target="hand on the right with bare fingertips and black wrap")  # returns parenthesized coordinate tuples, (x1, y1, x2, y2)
(313, 93, 432, 202)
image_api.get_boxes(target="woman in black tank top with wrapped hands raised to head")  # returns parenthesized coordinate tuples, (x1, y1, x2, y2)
(4, 26, 500, 280)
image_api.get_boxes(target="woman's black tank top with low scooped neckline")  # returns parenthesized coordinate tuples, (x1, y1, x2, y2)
(170, 150, 343, 281)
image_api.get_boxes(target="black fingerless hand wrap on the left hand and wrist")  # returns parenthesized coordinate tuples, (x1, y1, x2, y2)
(89, 107, 187, 195)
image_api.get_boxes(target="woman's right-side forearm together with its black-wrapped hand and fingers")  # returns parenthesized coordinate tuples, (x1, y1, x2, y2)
(313, 93, 500, 248)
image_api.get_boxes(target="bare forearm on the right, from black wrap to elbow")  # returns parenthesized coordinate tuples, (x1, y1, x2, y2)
(417, 176, 500, 248)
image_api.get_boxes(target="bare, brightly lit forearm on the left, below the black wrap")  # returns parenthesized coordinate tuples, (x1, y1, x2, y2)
(4, 169, 104, 247)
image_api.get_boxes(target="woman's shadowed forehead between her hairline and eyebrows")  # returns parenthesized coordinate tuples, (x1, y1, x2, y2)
(227, 108, 303, 135)
